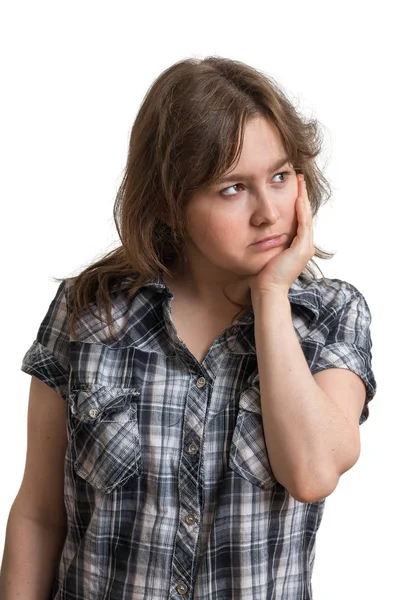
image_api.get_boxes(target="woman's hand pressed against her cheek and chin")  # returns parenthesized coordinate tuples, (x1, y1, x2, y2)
(249, 175, 315, 296)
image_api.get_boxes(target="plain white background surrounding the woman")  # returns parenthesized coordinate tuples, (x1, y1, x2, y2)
(0, 0, 398, 600)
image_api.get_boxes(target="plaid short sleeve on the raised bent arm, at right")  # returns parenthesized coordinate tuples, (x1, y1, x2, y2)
(311, 286, 377, 425)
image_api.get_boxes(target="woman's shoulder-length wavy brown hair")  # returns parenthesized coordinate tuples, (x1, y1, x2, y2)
(54, 56, 334, 339)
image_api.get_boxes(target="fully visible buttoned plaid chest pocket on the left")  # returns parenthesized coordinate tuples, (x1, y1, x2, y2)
(69, 385, 142, 494)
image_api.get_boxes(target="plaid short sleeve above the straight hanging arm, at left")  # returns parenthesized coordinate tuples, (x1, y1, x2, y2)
(21, 280, 70, 399)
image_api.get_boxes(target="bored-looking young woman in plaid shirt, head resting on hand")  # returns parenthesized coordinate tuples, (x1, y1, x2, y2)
(1, 57, 376, 600)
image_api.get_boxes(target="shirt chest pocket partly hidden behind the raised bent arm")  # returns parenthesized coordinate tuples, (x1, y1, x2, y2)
(229, 387, 277, 489)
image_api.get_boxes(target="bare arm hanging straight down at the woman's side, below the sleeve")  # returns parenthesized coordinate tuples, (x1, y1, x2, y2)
(0, 377, 67, 600)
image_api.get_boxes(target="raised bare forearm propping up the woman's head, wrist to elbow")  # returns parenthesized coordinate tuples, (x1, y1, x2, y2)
(252, 292, 352, 501)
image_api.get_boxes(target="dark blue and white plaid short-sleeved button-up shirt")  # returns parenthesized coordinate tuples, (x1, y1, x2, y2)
(21, 276, 376, 600)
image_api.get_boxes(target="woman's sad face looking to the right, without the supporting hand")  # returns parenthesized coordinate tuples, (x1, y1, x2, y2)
(186, 117, 298, 277)
